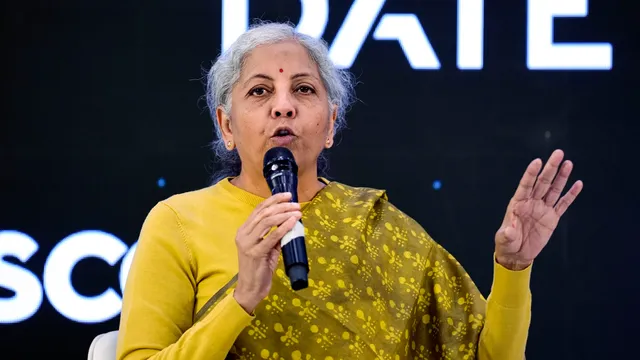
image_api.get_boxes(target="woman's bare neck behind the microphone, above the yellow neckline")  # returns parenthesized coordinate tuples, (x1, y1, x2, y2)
(231, 164, 325, 202)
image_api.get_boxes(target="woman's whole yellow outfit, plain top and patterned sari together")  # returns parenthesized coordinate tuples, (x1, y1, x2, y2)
(117, 179, 531, 360)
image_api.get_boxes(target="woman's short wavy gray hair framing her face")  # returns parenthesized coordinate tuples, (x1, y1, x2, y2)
(206, 22, 354, 183)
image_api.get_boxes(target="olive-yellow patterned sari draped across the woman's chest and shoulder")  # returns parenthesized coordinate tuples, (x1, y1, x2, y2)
(196, 182, 485, 360)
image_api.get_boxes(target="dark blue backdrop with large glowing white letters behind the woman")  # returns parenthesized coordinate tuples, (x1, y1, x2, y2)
(0, 0, 640, 359)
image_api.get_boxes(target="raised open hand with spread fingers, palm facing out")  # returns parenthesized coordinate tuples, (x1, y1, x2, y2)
(495, 150, 583, 270)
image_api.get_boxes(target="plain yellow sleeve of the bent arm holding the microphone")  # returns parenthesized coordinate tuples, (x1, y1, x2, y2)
(116, 202, 253, 360)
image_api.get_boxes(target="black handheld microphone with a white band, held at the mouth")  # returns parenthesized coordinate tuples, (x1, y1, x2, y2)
(262, 147, 309, 290)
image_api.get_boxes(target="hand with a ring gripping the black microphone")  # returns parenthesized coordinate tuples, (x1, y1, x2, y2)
(233, 193, 302, 313)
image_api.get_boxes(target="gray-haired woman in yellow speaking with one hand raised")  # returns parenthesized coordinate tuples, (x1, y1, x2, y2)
(118, 24, 582, 360)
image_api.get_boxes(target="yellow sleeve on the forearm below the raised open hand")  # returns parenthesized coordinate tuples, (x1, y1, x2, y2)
(478, 258, 531, 360)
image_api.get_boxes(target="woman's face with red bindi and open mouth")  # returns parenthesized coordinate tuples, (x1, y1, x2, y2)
(217, 41, 336, 178)
